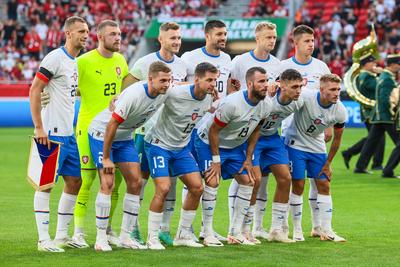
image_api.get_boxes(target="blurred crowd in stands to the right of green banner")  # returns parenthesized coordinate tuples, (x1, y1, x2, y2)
(295, 0, 400, 76)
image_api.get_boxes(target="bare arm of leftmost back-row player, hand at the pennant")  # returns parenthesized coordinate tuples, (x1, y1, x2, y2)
(29, 77, 51, 149)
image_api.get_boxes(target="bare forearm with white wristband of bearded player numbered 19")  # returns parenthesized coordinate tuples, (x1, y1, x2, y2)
(204, 122, 223, 185)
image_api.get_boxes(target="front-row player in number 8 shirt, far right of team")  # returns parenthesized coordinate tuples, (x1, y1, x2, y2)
(285, 74, 347, 242)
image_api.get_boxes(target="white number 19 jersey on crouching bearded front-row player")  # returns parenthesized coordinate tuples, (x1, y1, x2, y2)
(197, 90, 272, 149)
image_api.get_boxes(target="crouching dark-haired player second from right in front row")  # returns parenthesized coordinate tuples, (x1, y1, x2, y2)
(230, 69, 303, 243)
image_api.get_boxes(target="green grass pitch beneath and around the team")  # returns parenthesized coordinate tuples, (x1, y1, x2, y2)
(0, 128, 400, 266)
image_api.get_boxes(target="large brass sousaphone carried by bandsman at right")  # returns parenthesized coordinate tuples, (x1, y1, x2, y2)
(343, 25, 380, 108)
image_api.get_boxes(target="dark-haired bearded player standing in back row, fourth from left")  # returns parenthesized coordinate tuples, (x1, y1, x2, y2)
(182, 20, 237, 241)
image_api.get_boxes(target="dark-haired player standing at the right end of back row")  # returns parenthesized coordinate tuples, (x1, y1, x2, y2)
(281, 25, 332, 239)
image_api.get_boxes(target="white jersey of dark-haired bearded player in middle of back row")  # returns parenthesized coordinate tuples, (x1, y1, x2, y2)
(182, 47, 232, 98)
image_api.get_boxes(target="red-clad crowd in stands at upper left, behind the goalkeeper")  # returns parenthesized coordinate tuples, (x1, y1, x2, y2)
(0, 0, 219, 81)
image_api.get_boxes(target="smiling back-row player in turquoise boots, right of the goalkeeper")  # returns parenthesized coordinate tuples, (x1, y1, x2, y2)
(130, 22, 187, 245)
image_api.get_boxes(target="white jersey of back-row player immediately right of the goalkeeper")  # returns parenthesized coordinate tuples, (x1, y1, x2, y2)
(129, 51, 187, 135)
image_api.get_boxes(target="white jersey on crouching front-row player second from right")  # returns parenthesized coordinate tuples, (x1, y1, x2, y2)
(260, 90, 304, 136)
